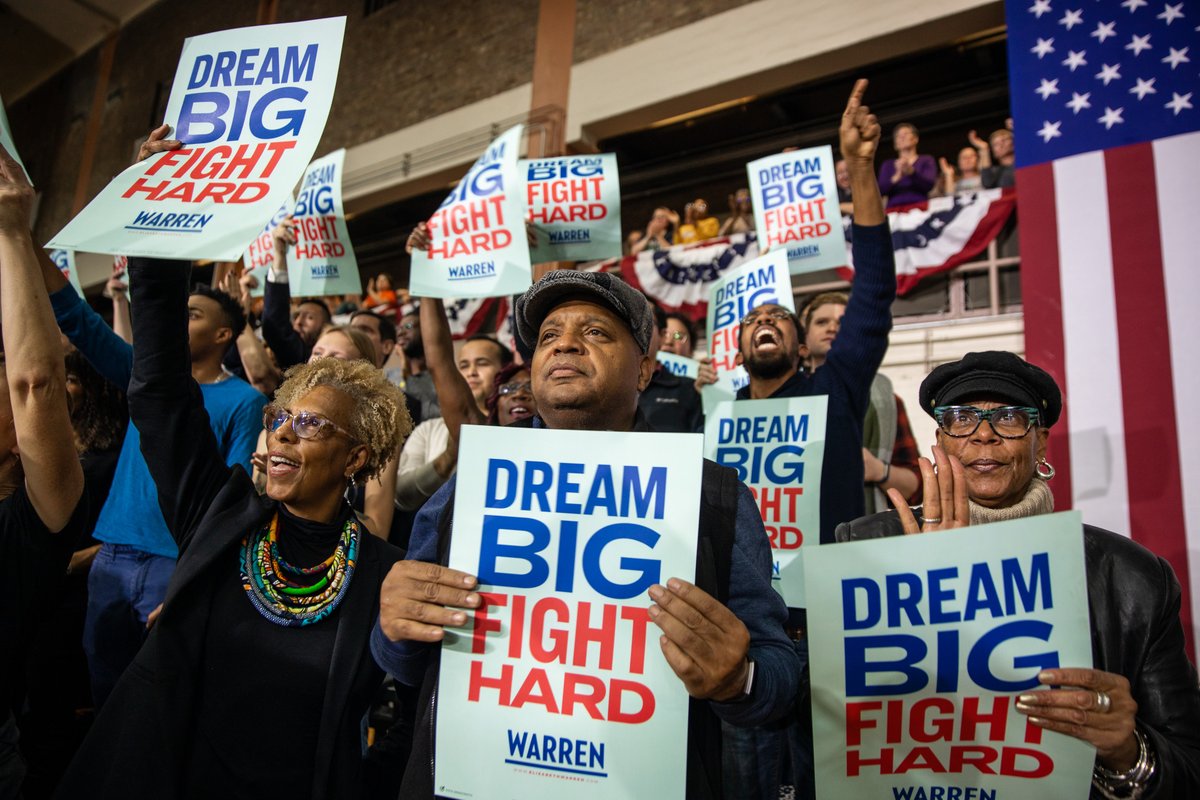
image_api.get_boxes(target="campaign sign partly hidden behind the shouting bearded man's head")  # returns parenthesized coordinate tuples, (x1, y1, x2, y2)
(700, 249, 796, 415)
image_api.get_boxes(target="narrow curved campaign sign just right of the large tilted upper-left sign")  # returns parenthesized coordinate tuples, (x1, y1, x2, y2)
(288, 150, 362, 297)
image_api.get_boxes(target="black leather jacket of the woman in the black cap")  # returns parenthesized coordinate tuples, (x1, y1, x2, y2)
(835, 511, 1200, 800)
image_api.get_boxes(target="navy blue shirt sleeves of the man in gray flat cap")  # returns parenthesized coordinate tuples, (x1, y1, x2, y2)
(371, 429, 803, 726)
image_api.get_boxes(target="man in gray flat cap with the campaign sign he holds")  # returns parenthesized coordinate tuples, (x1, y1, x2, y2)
(372, 217, 800, 798)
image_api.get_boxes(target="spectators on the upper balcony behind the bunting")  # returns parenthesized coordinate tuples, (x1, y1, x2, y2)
(625, 120, 1015, 255)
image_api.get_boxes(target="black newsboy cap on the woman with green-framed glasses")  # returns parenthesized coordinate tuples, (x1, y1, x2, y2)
(920, 350, 1062, 428)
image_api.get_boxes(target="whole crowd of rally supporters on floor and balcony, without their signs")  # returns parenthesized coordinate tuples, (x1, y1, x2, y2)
(0, 74, 1200, 800)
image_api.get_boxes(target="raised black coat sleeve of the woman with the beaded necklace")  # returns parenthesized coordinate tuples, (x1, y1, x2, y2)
(128, 258, 229, 549)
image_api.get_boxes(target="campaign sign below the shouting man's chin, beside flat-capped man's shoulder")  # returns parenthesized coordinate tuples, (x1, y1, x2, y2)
(704, 395, 829, 608)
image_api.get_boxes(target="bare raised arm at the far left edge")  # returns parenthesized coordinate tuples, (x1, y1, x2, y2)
(0, 146, 83, 533)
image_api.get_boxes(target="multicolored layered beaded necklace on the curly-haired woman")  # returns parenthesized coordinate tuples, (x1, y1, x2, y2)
(241, 512, 360, 627)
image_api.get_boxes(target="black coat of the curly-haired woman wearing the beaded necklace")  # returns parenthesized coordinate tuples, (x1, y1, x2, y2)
(58, 259, 400, 800)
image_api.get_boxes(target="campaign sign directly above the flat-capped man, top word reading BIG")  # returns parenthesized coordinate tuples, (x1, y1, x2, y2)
(520, 152, 622, 264)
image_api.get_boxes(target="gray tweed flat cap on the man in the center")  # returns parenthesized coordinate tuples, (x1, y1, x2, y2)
(515, 270, 654, 353)
